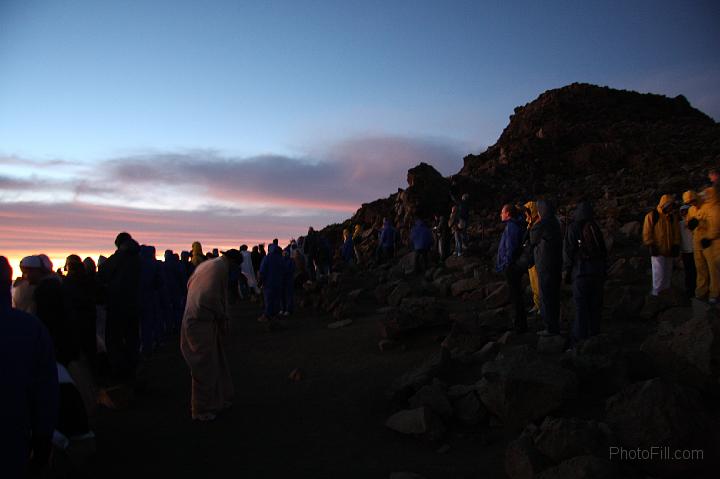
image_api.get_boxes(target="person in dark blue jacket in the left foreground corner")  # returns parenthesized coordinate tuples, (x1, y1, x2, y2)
(0, 256, 60, 478)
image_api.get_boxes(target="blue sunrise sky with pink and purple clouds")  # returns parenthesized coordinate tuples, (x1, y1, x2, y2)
(0, 0, 720, 276)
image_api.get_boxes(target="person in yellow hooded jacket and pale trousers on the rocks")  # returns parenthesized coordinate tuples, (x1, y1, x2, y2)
(643, 195, 680, 296)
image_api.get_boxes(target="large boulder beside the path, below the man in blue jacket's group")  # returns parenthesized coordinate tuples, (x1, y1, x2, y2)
(478, 346, 577, 429)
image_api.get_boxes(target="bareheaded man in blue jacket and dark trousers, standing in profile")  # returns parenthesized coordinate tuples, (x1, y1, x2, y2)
(495, 204, 527, 333)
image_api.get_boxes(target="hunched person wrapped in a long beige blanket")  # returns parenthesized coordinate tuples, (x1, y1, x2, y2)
(180, 249, 243, 421)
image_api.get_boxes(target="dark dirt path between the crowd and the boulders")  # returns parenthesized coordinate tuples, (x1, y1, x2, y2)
(93, 303, 502, 479)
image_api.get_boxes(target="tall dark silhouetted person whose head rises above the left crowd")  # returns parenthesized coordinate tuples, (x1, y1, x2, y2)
(98, 232, 141, 382)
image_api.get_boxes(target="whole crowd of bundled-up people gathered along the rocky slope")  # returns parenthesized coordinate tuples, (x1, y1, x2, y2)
(0, 170, 720, 477)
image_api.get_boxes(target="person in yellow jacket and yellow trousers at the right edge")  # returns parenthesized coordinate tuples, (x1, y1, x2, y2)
(683, 186, 720, 304)
